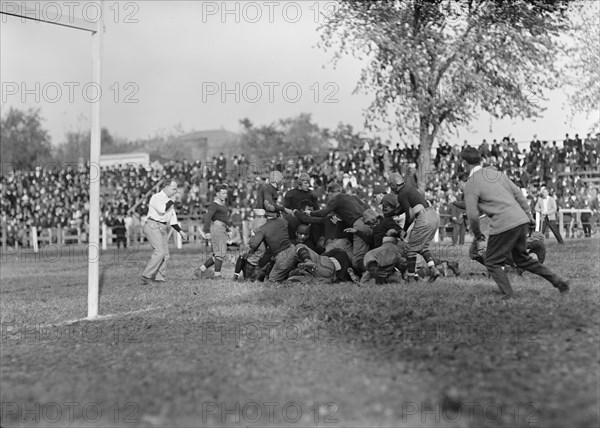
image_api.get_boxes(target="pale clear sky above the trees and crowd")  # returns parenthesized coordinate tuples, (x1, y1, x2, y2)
(0, 0, 597, 149)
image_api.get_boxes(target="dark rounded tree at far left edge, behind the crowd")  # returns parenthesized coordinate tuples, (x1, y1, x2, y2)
(0, 107, 52, 170)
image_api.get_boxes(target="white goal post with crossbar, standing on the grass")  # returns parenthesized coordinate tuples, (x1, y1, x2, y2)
(0, 0, 104, 319)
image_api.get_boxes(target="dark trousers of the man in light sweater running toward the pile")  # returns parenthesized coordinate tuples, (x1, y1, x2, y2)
(485, 224, 560, 294)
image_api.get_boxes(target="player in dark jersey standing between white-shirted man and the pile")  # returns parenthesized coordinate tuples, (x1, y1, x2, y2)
(194, 184, 230, 279)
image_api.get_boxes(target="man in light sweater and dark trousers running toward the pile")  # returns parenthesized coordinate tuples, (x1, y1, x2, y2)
(462, 147, 569, 298)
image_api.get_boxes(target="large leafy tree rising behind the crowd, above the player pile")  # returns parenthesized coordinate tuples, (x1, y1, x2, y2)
(321, 0, 568, 186)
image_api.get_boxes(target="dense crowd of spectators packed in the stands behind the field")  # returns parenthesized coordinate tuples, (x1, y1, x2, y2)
(0, 134, 600, 247)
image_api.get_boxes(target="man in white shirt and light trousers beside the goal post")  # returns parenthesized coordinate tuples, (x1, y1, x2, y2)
(142, 181, 187, 284)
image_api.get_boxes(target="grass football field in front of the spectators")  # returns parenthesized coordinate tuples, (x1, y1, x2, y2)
(0, 239, 600, 427)
